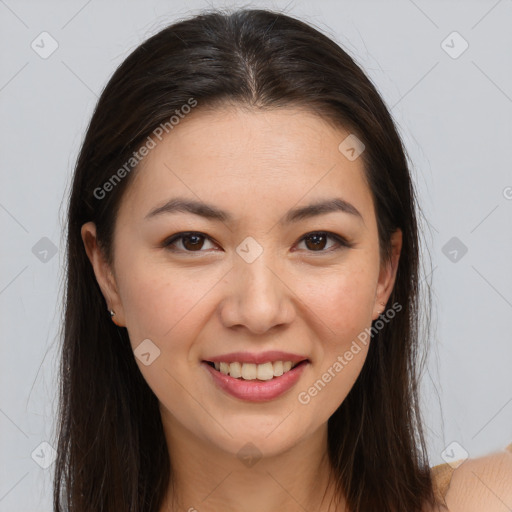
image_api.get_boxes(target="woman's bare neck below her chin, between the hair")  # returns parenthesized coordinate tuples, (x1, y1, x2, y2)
(160, 411, 344, 512)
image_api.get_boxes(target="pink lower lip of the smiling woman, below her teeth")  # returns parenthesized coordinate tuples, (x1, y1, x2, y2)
(201, 361, 309, 402)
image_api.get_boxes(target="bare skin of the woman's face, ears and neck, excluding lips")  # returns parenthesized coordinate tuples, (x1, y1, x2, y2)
(82, 107, 402, 512)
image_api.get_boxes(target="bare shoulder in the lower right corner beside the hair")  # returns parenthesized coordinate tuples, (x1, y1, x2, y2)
(432, 444, 512, 512)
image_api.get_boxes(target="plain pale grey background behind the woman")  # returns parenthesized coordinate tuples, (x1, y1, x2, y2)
(0, 0, 512, 512)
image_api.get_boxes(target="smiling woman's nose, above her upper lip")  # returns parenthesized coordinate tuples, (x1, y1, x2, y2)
(220, 253, 295, 334)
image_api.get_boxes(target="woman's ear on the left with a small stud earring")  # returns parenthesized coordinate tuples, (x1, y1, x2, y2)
(81, 222, 125, 327)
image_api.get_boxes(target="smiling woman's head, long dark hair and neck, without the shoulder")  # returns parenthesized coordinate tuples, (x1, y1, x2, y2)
(54, 10, 512, 512)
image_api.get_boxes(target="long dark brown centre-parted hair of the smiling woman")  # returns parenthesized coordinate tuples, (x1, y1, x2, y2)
(54, 9, 435, 512)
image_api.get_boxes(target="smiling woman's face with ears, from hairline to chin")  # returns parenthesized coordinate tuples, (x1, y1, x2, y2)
(82, 108, 401, 456)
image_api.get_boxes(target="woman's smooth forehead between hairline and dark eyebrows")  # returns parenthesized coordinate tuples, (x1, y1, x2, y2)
(120, 107, 373, 222)
